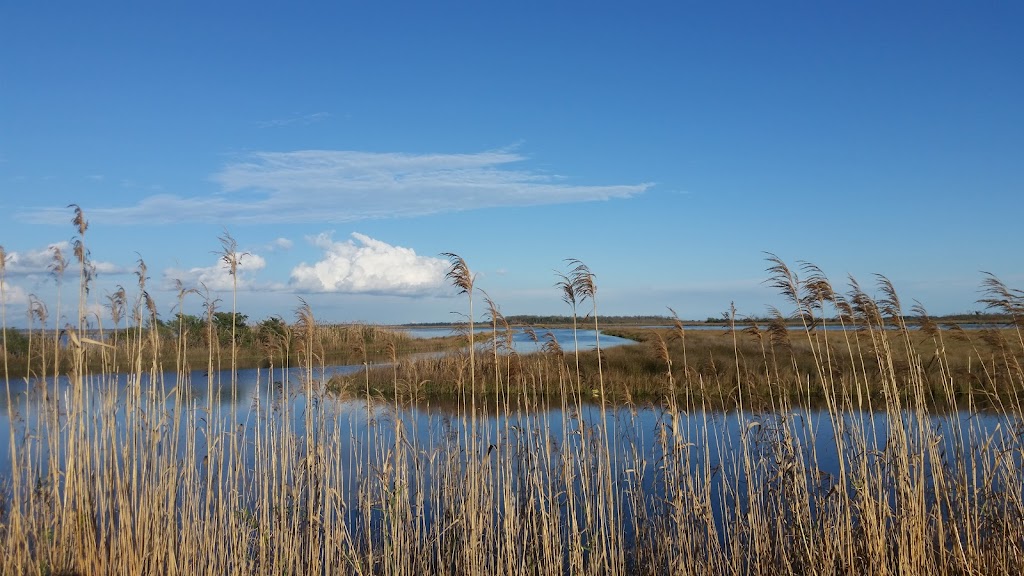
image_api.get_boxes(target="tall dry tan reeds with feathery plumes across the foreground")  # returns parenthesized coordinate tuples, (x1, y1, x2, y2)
(0, 217, 1024, 575)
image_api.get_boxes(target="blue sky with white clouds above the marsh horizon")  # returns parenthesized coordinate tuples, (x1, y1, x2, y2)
(0, 1, 1024, 324)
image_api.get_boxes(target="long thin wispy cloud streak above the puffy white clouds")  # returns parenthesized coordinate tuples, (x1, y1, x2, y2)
(19, 150, 652, 223)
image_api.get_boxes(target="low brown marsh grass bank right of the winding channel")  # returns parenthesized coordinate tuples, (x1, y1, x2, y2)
(330, 327, 1024, 410)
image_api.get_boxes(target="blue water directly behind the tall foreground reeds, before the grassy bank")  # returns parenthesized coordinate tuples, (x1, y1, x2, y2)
(0, 348, 1024, 496)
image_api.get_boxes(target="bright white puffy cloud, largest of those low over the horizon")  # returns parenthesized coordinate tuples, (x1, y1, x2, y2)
(291, 233, 447, 296)
